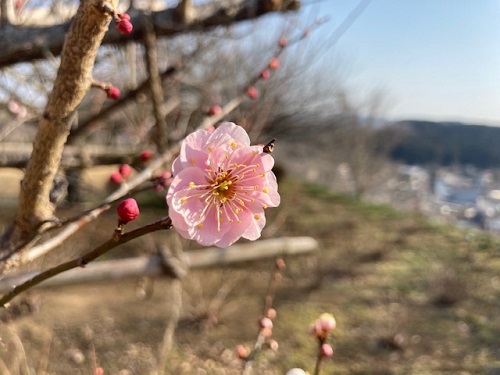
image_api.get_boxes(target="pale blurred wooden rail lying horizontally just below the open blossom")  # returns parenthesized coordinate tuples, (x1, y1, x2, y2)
(0, 237, 318, 293)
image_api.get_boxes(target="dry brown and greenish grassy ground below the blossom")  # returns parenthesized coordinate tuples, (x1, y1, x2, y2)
(0, 182, 500, 375)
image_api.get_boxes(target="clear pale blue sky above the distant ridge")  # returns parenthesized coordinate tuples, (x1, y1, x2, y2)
(302, 0, 500, 126)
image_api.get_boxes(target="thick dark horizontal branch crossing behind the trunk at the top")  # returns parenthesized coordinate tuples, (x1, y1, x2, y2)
(0, 0, 296, 67)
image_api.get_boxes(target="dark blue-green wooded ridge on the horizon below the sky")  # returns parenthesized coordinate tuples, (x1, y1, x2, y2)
(386, 120, 500, 168)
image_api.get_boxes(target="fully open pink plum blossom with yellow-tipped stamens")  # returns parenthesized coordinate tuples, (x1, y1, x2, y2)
(167, 122, 280, 247)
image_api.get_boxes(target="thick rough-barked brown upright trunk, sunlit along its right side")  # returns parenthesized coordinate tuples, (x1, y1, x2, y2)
(0, 0, 117, 258)
